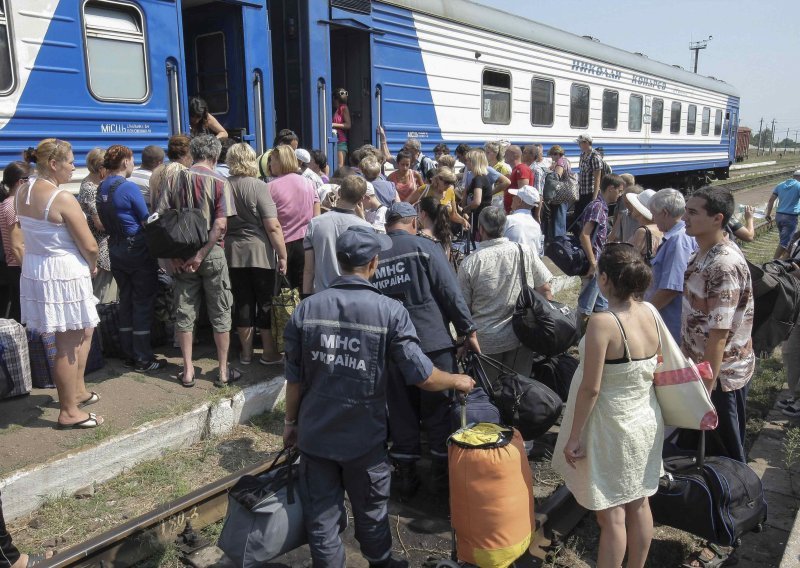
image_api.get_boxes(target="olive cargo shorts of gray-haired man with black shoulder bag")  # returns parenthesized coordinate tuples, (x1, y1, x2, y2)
(173, 245, 233, 333)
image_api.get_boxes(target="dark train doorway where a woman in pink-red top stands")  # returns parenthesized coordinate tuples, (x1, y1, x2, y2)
(328, 25, 375, 163)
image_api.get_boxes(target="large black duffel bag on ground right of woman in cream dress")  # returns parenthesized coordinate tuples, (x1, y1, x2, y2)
(650, 432, 767, 546)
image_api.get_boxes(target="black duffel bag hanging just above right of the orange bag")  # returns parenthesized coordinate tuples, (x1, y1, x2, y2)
(477, 354, 564, 440)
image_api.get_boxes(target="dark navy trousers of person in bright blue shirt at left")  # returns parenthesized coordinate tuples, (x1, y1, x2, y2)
(108, 233, 158, 362)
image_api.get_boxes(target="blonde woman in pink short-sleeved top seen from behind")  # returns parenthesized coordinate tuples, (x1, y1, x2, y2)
(267, 145, 319, 289)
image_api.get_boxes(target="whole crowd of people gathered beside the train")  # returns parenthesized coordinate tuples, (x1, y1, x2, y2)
(0, 95, 800, 567)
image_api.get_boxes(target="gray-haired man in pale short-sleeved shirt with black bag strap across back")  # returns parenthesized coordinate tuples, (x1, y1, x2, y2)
(458, 207, 553, 379)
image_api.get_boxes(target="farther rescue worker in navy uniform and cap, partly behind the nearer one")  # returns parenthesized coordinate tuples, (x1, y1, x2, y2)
(372, 202, 480, 501)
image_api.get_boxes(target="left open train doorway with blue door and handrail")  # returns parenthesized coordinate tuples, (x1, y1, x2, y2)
(181, 0, 272, 152)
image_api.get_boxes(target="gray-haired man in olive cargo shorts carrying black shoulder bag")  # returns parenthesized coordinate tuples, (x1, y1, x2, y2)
(157, 134, 241, 387)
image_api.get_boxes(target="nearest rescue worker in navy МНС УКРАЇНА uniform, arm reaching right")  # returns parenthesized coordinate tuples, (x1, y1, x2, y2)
(283, 226, 474, 568)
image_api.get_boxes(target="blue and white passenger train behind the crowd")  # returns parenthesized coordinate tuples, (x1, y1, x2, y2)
(0, 0, 739, 187)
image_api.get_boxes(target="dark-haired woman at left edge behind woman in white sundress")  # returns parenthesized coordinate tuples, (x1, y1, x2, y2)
(0, 162, 31, 321)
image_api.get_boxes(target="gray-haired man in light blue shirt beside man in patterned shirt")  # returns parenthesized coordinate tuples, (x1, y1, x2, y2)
(644, 188, 697, 345)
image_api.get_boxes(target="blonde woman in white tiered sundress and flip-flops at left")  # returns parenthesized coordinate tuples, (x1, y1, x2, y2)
(16, 138, 103, 428)
